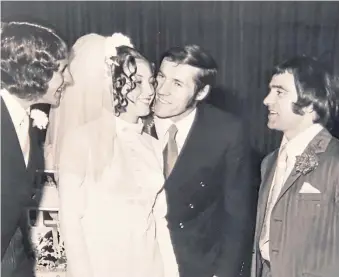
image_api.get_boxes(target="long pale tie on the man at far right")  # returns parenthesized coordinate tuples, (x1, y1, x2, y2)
(259, 144, 287, 261)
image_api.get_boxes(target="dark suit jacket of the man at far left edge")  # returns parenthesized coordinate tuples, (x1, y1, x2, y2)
(1, 99, 43, 277)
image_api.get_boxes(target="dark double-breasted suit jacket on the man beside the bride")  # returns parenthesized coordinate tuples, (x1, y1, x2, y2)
(155, 104, 258, 277)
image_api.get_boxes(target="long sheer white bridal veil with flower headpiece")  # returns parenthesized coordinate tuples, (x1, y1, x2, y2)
(45, 34, 132, 179)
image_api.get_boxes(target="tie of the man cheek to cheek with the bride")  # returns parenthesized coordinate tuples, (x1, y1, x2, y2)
(163, 124, 178, 179)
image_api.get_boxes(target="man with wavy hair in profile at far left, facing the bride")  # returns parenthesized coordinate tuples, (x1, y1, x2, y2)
(1, 22, 71, 277)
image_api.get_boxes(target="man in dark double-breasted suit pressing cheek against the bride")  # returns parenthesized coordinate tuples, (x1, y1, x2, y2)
(154, 45, 256, 277)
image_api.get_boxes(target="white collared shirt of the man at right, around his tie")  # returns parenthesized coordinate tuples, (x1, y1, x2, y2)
(260, 124, 323, 261)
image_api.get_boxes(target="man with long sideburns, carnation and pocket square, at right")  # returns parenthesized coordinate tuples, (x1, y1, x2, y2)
(251, 56, 339, 277)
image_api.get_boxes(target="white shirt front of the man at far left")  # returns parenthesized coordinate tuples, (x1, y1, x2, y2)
(0, 89, 30, 166)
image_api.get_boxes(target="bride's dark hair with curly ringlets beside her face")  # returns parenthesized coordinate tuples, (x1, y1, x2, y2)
(112, 46, 154, 116)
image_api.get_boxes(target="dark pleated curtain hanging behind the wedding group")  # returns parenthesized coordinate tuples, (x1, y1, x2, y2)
(1, 1, 339, 156)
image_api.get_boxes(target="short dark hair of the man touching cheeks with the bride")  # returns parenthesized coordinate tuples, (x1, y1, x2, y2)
(161, 44, 218, 92)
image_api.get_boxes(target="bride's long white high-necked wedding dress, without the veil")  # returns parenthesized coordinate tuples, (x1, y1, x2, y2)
(59, 113, 177, 277)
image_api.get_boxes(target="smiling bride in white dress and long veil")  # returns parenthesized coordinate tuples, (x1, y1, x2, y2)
(47, 34, 177, 277)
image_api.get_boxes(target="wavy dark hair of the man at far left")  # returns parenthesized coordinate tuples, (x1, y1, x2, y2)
(1, 22, 68, 100)
